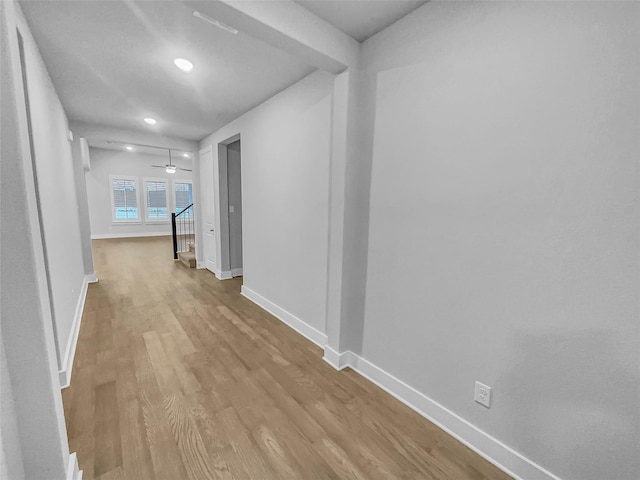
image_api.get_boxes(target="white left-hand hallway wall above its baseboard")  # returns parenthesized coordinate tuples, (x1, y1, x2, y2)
(17, 0, 85, 376)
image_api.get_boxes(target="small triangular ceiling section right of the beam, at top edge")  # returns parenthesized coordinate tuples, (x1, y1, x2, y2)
(294, 0, 426, 42)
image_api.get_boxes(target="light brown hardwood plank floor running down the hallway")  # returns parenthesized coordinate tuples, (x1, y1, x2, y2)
(63, 237, 510, 480)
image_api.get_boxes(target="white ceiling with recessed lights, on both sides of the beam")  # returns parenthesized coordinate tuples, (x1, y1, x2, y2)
(20, 0, 424, 140)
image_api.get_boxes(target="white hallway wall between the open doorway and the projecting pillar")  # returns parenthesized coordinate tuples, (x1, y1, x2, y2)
(199, 72, 333, 338)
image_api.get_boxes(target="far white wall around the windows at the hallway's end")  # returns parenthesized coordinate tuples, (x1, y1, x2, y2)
(86, 148, 193, 238)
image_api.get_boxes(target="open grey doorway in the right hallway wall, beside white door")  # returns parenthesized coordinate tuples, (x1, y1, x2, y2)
(218, 135, 243, 278)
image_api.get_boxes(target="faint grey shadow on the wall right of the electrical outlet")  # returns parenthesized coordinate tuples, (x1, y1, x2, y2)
(504, 330, 640, 480)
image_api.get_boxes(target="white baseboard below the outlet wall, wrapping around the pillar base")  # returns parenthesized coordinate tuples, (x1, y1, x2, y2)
(324, 347, 560, 480)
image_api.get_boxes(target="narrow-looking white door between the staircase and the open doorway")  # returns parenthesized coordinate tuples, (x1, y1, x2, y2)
(200, 147, 216, 273)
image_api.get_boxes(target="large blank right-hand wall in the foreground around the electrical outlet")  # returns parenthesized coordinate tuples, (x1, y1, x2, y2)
(362, 2, 640, 480)
